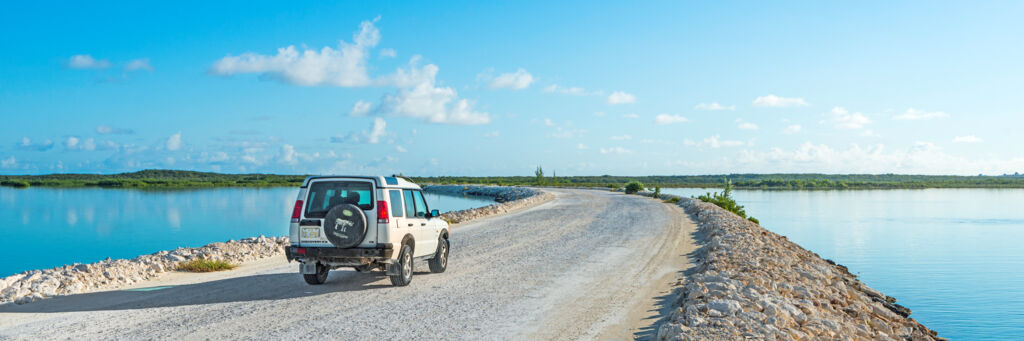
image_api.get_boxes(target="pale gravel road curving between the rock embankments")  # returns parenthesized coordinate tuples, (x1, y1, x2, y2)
(0, 189, 695, 340)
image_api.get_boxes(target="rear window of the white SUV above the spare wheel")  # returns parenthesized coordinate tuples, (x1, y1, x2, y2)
(306, 181, 374, 218)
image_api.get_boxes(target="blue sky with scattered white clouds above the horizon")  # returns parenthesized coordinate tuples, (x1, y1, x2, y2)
(0, 1, 1024, 175)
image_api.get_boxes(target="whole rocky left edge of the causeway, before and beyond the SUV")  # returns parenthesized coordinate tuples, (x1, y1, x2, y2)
(0, 185, 553, 304)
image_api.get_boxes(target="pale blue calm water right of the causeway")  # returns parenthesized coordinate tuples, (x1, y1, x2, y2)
(662, 188, 1024, 340)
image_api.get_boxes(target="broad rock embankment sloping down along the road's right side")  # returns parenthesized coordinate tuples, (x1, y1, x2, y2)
(657, 196, 941, 340)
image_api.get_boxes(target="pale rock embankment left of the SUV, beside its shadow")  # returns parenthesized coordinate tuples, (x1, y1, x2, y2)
(0, 236, 289, 304)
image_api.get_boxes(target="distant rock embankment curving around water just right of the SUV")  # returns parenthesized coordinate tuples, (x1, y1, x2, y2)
(423, 184, 554, 223)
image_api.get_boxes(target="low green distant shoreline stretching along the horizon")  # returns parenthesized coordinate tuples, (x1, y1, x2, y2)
(0, 170, 1024, 190)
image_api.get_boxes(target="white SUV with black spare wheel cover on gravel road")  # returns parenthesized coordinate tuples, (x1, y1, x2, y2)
(286, 175, 450, 286)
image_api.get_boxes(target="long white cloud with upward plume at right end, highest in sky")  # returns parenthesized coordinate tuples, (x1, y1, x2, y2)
(210, 17, 380, 87)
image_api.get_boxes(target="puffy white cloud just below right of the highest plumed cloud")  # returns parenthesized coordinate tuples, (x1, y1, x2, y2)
(374, 57, 490, 125)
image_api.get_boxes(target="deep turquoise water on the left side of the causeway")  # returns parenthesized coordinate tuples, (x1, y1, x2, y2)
(0, 187, 494, 276)
